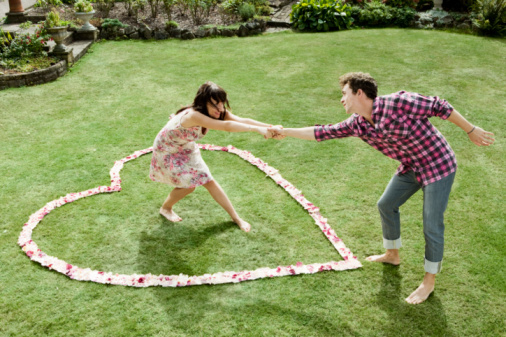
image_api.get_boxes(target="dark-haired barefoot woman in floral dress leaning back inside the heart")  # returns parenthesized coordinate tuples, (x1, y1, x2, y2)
(149, 82, 271, 232)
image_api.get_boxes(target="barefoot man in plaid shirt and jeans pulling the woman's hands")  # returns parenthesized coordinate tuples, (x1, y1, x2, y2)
(270, 73, 494, 304)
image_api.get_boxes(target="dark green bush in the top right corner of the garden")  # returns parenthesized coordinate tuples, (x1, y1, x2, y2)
(473, 0, 506, 36)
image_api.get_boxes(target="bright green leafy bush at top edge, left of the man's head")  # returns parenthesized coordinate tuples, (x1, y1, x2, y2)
(290, 0, 353, 31)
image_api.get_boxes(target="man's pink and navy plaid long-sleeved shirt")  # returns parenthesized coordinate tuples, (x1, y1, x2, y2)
(314, 91, 457, 186)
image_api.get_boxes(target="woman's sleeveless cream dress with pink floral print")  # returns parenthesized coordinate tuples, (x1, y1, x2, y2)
(149, 111, 213, 188)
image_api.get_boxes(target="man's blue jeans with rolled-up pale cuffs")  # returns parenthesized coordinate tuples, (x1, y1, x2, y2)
(378, 171, 455, 274)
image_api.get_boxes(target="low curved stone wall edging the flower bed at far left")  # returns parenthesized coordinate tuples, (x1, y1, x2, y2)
(0, 60, 67, 90)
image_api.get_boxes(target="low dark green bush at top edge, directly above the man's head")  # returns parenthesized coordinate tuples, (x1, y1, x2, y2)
(352, 2, 416, 27)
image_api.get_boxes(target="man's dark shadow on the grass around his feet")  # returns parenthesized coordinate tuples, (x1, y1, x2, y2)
(377, 265, 454, 336)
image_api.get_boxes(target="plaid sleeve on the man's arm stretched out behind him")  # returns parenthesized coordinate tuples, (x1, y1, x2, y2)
(397, 91, 453, 119)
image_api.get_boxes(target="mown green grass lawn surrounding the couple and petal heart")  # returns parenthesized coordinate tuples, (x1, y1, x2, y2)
(0, 29, 506, 337)
